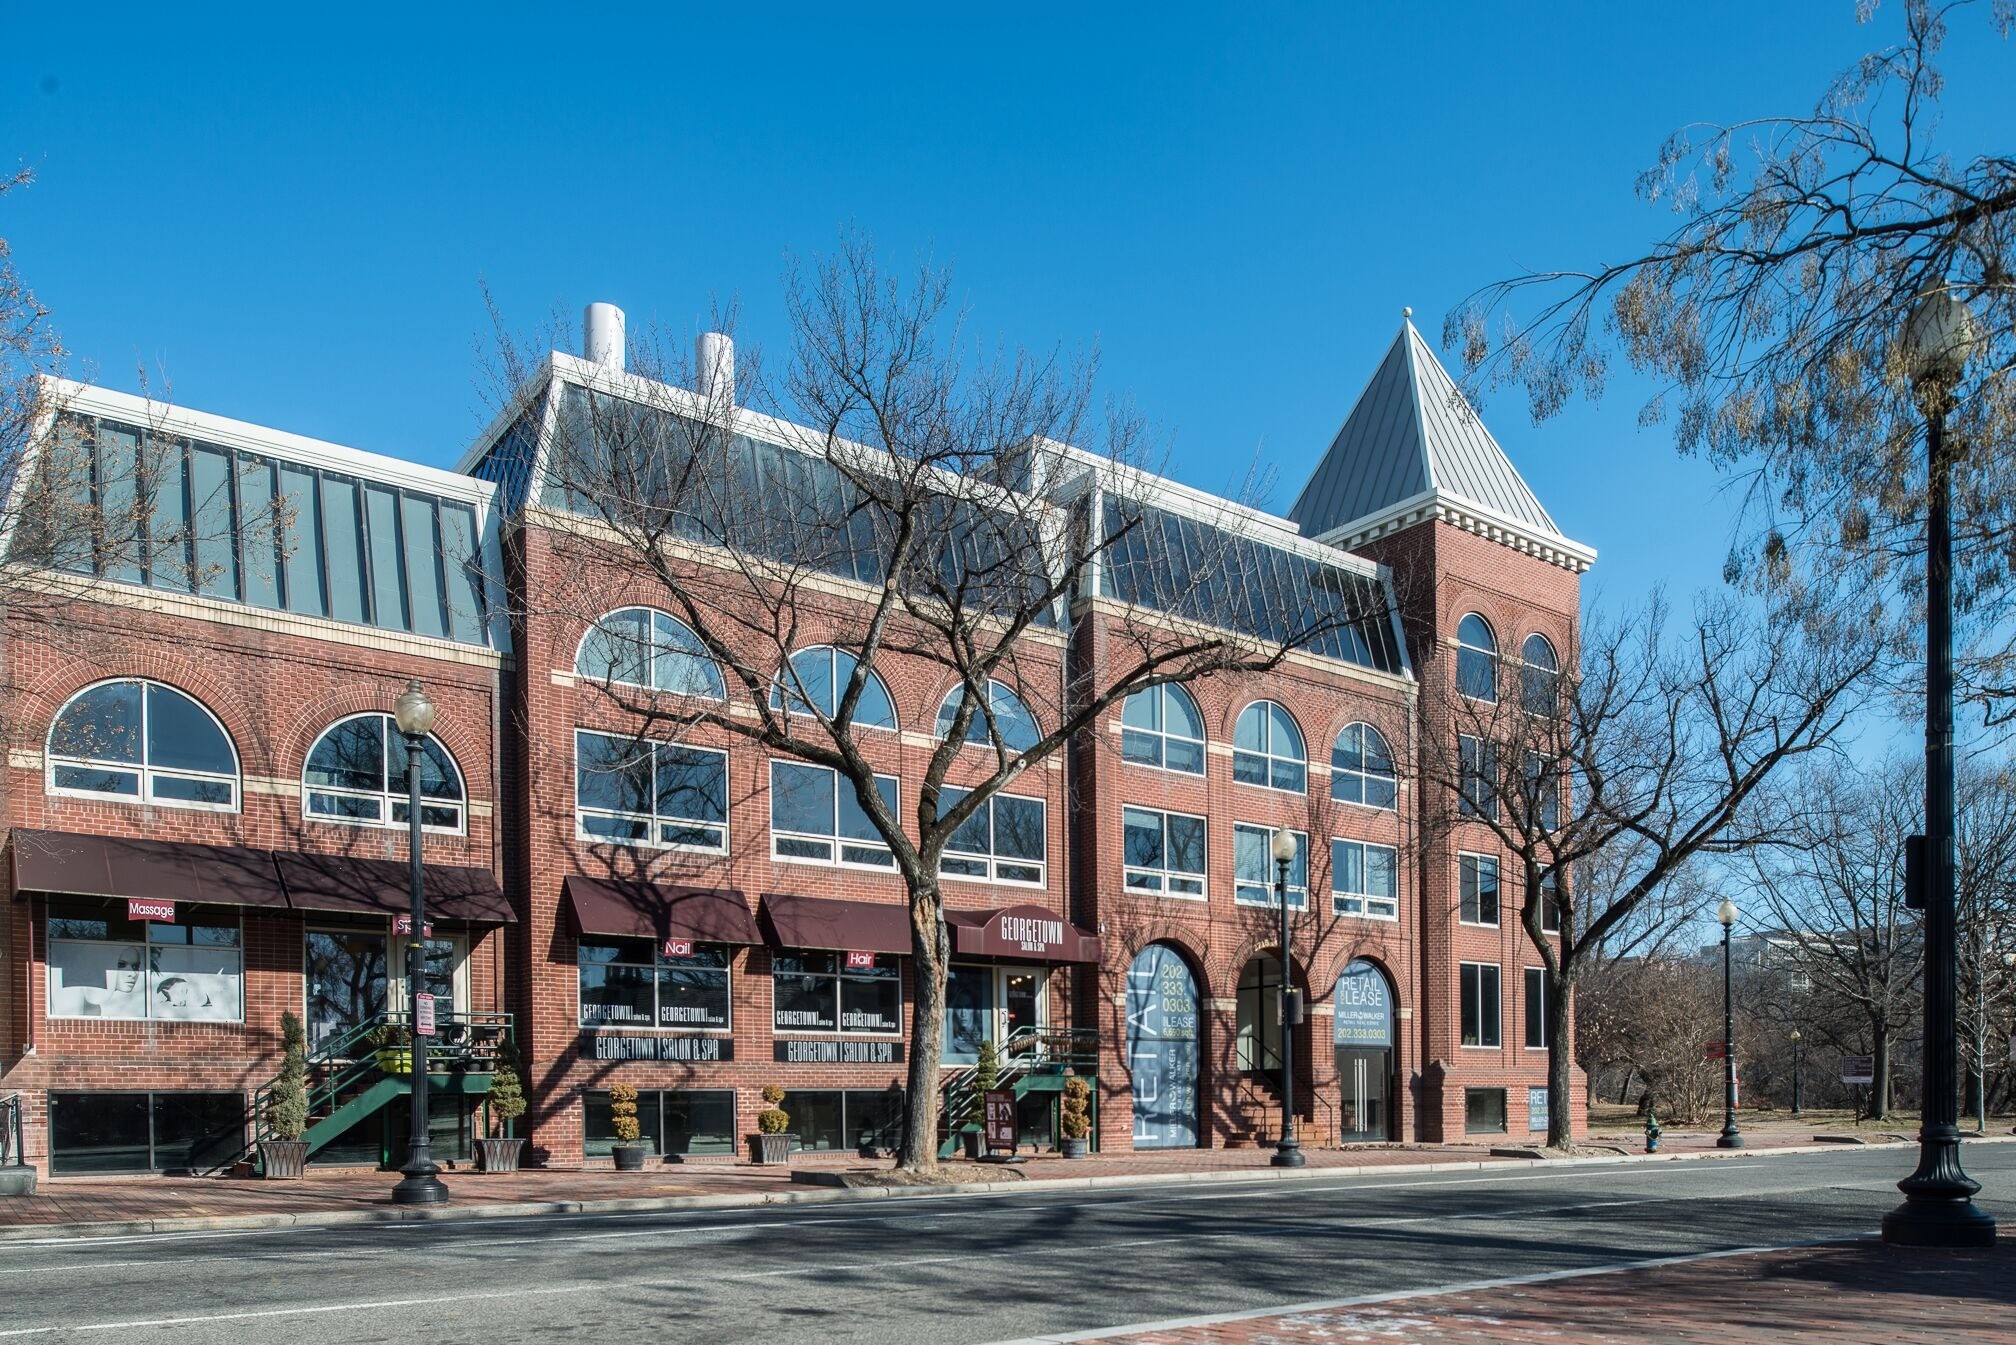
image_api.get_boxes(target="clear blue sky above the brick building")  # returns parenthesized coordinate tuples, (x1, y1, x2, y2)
(0, 0, 2016, 617)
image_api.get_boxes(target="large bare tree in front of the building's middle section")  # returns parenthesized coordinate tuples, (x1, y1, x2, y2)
(487, 240, 1389, 1170)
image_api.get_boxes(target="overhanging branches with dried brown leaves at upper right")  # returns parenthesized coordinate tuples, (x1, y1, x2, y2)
(1445, 0, 2016, 724)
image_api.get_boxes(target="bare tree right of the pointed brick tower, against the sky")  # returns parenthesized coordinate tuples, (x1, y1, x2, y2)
(1421, 593, 1881, 1145)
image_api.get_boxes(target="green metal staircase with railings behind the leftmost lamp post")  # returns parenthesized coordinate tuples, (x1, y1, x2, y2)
(216, 1010, 512, 1170)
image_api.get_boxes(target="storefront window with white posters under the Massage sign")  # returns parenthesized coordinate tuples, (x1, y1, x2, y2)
(48, 907, 244, 1022)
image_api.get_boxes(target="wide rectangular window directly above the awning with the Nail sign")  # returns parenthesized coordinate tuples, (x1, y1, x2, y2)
(575, 728, 728, 855)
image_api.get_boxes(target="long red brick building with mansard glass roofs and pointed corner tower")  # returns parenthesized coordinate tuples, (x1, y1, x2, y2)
(0, 304, 1593, 1174)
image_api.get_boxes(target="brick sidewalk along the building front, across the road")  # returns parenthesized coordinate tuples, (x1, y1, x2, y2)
(0, 1131, 1927, 1240)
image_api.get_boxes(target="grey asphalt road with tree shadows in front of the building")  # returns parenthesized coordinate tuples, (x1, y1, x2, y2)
(0, 1143, 2016, 1345)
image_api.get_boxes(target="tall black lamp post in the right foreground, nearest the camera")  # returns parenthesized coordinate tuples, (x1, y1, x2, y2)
(1883, 288, 1996, 1246)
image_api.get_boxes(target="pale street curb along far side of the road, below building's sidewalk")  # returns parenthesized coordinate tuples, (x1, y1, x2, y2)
(0, 1135, 2016, 1242)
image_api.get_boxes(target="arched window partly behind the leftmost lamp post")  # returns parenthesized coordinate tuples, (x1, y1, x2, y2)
(300, 714, 464, 833)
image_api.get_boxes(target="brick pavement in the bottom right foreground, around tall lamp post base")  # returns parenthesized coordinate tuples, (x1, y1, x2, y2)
(1081, 1238, 2016, 1345)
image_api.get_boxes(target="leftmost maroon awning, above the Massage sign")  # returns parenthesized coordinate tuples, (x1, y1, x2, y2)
(14, 827, 286, 909)
